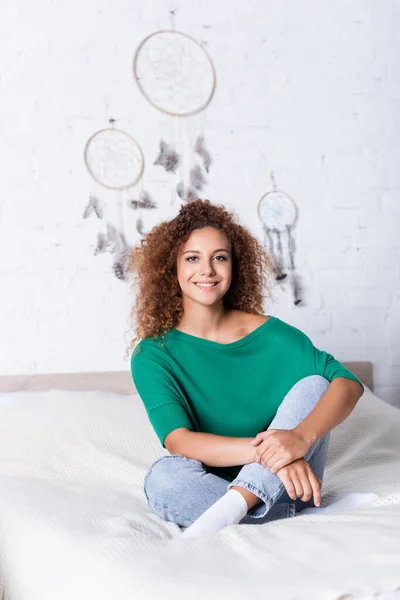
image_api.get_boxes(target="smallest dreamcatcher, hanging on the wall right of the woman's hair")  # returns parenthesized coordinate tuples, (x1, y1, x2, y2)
(258, 173, 301, 305)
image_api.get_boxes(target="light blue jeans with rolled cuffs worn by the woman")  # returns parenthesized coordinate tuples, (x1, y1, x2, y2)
(144, 375, 330, 527)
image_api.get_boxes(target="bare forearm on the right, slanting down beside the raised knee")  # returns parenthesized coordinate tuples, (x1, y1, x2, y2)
(294, 377, 363, 446)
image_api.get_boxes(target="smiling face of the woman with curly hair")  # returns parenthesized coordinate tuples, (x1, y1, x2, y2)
(177, 227, 232, 306)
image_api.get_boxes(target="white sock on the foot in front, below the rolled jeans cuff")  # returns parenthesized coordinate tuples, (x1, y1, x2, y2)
(181, 490, 248, 538)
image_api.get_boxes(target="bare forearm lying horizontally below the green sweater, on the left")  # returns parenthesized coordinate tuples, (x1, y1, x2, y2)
(174, 431, 255, 467)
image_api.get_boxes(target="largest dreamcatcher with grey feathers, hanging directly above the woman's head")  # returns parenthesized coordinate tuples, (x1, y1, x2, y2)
(133, 11, 215, 202)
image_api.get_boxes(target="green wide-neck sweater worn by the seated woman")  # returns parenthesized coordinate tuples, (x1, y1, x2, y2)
(131, 316, 362, 481)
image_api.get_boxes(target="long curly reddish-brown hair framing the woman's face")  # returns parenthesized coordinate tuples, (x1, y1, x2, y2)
(127, 200, 272, 353)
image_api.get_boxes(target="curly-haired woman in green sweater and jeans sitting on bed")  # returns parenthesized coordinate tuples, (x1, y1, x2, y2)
(127, 200, 363, 538)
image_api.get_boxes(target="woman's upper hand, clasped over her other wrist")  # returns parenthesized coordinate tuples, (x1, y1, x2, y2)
(250, 429, 311, 473)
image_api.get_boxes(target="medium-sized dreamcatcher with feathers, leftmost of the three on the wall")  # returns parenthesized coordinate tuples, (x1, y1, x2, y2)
(83, 119, 155, 279)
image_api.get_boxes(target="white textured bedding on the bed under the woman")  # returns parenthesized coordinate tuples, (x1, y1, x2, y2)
(0, 389, 400, 600)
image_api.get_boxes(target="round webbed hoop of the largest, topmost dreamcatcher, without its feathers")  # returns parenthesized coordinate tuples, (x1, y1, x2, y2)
(133, 29, 216, 117)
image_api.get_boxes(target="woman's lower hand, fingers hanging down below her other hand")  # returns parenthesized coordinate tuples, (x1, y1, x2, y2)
(276, 458, 322, 506)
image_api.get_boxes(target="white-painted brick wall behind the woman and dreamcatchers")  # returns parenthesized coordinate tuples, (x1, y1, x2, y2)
(0, 0, 400, 406)
